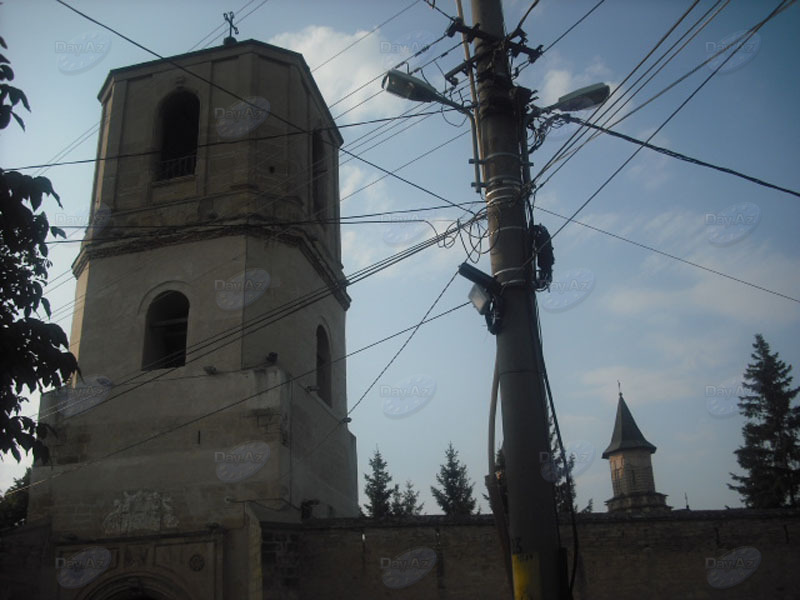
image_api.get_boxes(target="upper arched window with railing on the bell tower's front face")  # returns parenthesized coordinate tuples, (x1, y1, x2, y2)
(157, 92, 200, 180)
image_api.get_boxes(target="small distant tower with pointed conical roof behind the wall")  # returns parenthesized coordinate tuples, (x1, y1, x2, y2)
(603, 392, 670, 512)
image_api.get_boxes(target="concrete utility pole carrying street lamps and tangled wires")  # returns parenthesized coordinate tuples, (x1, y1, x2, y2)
(472, 0, 565, 600)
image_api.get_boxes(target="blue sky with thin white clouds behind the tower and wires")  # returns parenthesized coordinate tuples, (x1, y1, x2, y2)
(0, 0, 800, 514)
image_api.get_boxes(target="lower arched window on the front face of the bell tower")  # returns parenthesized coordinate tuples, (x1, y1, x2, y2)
(142, 291, 189, 371)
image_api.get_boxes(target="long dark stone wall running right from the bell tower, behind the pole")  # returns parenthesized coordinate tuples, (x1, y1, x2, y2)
(262, 509, 800, 600)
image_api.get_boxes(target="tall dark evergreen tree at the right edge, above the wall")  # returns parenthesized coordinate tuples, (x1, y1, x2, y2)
(728, 334, 800, 508)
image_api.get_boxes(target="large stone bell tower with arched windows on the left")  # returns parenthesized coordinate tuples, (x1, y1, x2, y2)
(29, 40, 358, 600)
